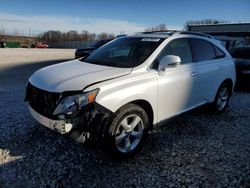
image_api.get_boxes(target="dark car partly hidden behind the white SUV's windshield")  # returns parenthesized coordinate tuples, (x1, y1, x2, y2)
(75, 39, 113, 59)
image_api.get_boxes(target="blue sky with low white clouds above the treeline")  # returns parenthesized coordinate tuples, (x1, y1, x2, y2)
(0, 0, 250, 35)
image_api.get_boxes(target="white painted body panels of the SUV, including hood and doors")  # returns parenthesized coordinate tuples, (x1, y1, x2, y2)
(30, 34, 236, 123)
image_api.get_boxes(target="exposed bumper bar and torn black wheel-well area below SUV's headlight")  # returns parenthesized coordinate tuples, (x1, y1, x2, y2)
(28, 103, 113, 136)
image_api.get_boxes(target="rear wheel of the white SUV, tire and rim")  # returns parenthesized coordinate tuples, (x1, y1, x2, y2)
(212, 83, 230, 114)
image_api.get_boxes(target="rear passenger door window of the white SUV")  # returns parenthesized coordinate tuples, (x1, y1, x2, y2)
(191, 39, 216, 61)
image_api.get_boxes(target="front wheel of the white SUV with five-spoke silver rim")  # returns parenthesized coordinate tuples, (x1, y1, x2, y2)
(106, 104, 149, 158)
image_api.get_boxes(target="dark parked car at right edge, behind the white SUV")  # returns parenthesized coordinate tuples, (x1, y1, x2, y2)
(230, 46, 250, 86)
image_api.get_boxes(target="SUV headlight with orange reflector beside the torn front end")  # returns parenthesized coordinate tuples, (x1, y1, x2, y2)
(53, 89, 99, 116)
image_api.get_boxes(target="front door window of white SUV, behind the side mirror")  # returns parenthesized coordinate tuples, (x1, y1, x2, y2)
(158, 38, 192, 64)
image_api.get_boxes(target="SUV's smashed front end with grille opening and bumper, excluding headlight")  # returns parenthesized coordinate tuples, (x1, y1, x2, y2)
(25, 83, 113, 139)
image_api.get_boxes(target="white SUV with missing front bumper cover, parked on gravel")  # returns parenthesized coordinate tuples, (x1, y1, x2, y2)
(26, 32, 235, 156)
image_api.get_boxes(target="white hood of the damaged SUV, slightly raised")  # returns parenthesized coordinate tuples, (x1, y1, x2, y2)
(29, 60, 132, 92)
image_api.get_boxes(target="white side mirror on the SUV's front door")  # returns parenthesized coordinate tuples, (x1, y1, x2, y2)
(158, 55, 181, 71)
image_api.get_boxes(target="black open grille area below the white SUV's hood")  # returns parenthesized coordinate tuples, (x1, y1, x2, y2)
(25, 83, 60, 118)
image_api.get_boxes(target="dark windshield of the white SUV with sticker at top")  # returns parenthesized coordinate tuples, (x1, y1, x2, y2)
(82, 37, 163, 68)
